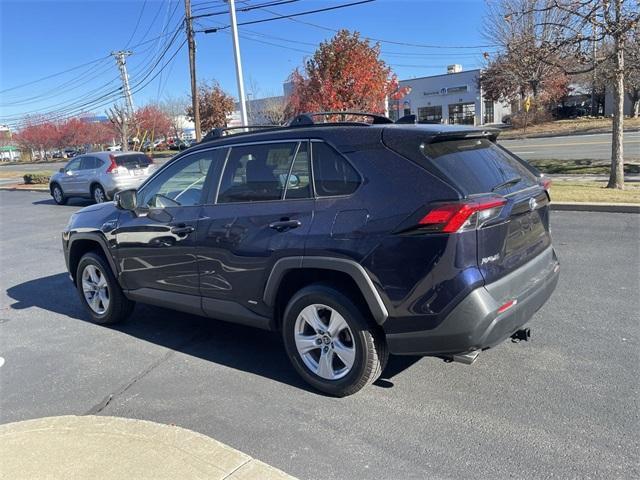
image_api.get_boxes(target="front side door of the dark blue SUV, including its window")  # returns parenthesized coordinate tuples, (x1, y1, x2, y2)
(115, 150, 222, 298)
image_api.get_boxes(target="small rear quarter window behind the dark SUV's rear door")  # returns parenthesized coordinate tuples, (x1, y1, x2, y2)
(311, 142, 360, 197)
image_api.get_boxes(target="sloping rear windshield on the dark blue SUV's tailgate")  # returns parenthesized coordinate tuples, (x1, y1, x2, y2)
(420, 138, 537, 195)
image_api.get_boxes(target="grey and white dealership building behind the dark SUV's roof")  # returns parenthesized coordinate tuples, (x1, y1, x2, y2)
(389, 64, 511, 125)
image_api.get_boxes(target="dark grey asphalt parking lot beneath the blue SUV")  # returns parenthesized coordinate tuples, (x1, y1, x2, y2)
(0, 191, 640, 479)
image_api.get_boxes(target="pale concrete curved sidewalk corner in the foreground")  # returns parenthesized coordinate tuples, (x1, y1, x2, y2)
(0, 416, 295, 480)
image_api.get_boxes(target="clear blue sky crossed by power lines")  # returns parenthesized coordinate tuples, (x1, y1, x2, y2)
(0, 0, 495, 125)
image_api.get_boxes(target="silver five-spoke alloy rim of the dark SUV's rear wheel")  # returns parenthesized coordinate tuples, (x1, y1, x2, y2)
(294, 304, 356, 380)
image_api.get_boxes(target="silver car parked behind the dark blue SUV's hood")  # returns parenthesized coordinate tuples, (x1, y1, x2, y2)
(49, 152, 155, 205)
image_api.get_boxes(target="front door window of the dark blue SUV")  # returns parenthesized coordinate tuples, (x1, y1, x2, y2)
(138, 150, 217, 208)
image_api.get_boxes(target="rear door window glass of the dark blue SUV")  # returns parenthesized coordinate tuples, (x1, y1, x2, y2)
(218, 142, 299, 203)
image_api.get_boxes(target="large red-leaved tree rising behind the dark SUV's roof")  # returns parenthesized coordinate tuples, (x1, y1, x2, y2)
(289, 30, 403, 113)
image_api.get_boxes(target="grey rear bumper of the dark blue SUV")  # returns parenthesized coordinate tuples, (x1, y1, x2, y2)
(386, 247, 559, 355)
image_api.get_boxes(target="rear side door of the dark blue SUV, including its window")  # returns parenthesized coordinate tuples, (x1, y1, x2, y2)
(198, 140, 314, 316)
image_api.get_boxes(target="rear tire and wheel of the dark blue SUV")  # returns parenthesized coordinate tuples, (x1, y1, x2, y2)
(282, 284, 389, 397)
